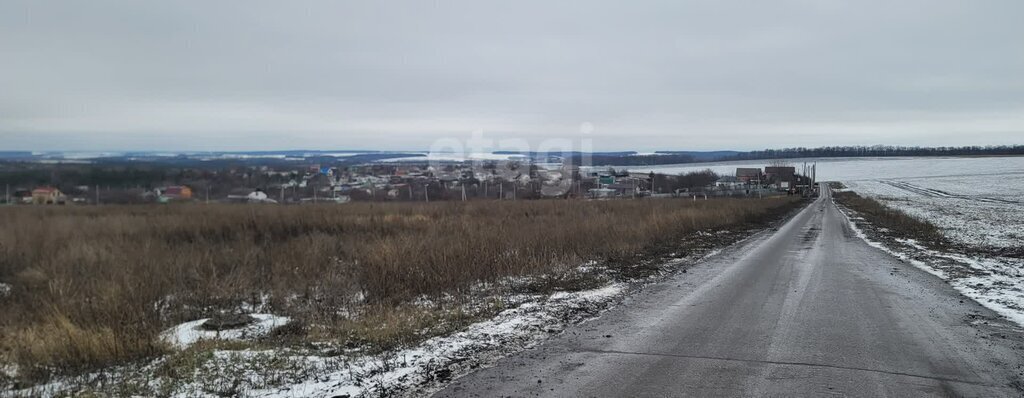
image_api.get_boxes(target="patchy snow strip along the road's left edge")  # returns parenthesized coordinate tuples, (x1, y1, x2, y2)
(240, 283, 625, 398)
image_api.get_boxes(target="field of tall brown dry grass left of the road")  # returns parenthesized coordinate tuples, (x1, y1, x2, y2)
(0, 197, 797, 378)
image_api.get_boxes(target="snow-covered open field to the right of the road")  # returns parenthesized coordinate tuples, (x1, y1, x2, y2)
(806, 158, 1024, 324)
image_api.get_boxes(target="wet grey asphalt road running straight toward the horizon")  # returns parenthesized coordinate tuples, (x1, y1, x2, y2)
(436, 187, 1024, 397)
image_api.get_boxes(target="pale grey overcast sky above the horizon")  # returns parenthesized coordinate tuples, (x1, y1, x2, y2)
(0, 0, 1024, 150)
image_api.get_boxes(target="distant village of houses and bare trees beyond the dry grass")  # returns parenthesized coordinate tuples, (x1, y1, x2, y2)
(0, 160, 814, 205)
